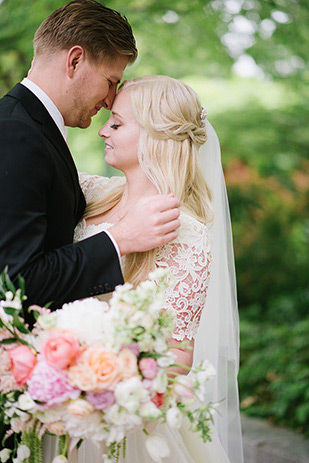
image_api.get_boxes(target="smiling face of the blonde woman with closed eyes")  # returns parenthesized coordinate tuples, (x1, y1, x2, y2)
(99, 90, 140, 173)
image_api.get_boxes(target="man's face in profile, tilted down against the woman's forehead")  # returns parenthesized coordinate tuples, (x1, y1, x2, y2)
(65, 56, 128, 129)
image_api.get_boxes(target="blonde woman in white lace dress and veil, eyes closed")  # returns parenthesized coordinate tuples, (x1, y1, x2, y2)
(44, 76, 243, 463)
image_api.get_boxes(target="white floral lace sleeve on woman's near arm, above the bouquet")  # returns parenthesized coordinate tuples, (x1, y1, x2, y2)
(156, 212, 212, 341)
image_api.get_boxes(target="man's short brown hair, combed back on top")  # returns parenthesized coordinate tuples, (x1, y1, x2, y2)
(33, 0, 137, 63)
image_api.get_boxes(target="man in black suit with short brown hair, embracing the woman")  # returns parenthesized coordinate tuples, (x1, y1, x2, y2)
(0, 0, 179, 308)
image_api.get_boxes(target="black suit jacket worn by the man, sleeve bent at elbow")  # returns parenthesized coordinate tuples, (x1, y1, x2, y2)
(0, 84, 123, 314)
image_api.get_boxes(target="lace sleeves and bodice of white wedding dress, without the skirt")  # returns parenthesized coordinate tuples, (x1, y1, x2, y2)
(74, 174, 212, 341)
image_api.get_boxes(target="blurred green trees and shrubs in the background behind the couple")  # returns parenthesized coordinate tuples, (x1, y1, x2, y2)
(0, 0, 309, 432)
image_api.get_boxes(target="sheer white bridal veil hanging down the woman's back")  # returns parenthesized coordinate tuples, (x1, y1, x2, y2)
(194, 120, 243, 463)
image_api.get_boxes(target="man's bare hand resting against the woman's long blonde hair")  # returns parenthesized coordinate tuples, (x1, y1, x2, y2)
(108, 194, 180, 256)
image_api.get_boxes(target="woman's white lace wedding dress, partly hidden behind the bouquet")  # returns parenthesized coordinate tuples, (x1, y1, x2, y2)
(43, 174, 229, 463)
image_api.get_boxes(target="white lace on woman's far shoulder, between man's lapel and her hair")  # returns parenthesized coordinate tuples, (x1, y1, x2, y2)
(78, 172, 126, 203)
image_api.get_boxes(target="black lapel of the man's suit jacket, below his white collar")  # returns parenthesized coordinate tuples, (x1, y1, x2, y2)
(7, 84, 85, 220)
